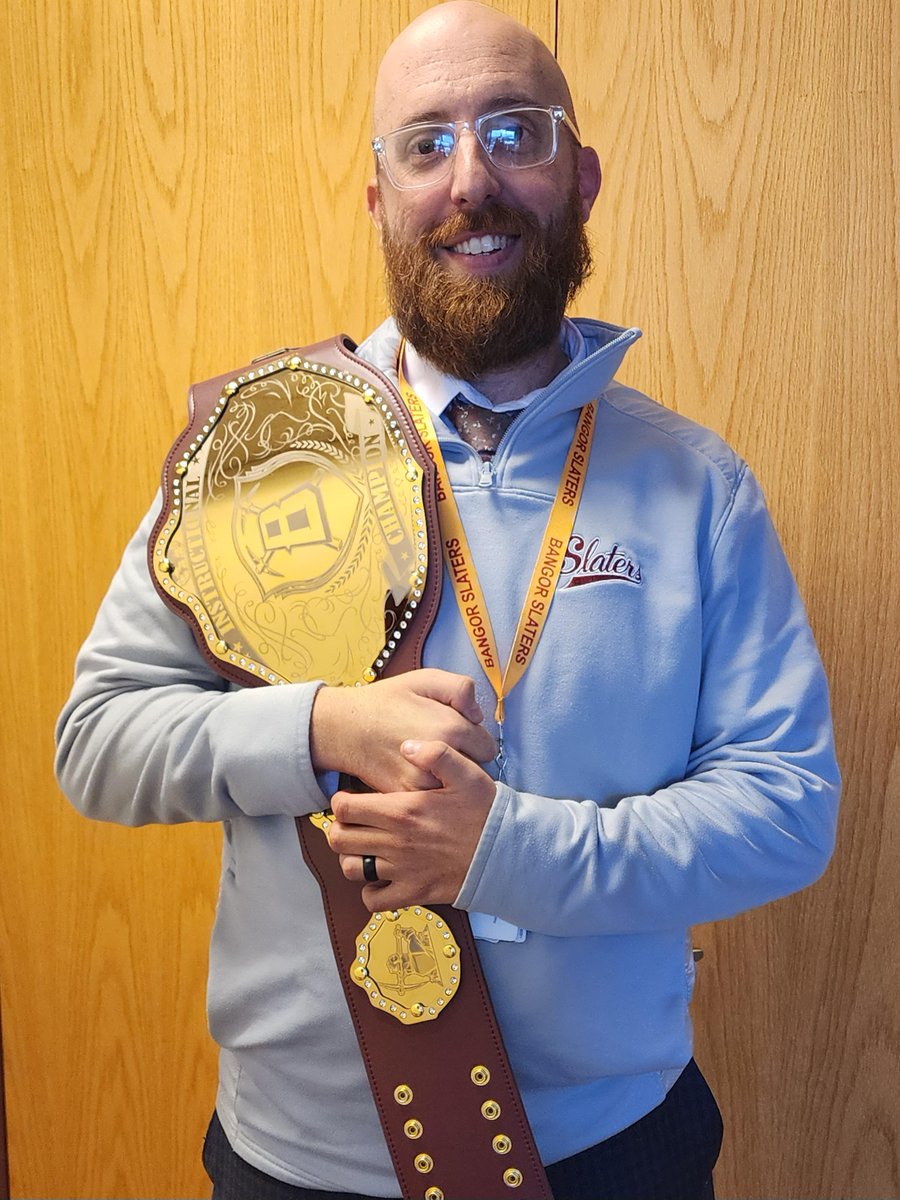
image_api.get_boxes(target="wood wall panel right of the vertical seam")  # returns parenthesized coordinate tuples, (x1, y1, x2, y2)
(559, 0, 900, 1200)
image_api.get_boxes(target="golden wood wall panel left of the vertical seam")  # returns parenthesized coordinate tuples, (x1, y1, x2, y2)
(0, 0, 554, 1200)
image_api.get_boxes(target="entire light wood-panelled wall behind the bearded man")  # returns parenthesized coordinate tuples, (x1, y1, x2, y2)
(0, 0, 900, 1200)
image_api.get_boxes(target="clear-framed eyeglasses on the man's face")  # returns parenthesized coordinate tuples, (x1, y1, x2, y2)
(372, 104, 581, 188)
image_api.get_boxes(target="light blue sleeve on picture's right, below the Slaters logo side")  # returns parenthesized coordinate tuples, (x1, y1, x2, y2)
(455, 468, 840, 936)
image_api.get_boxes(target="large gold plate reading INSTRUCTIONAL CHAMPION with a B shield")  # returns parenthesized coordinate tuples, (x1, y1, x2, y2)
(151, 355, 428, 685)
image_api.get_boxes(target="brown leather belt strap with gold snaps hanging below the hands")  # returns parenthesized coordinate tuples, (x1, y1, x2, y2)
(296, 817, 553, 1200)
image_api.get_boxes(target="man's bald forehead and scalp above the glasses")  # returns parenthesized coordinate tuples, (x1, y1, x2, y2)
(374, 4, 571, 132)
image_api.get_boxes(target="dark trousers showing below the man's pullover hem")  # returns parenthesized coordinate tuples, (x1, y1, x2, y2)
(203, 1060, 722, 1200)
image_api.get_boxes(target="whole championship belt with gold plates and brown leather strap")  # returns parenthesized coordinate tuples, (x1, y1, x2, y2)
(148, 336, 552, 1200)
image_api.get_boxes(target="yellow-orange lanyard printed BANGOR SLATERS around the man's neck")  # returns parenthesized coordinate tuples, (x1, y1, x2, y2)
(398, 347, 595, 778)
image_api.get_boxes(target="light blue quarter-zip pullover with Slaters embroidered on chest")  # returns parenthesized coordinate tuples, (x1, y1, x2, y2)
(58, 320, 839, 1196)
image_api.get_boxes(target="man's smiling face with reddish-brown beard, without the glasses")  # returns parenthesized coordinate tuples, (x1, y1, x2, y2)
(368, 9, 599, 378)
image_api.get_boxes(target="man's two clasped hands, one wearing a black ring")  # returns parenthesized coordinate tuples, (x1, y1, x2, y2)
(311, 670, 496, 912)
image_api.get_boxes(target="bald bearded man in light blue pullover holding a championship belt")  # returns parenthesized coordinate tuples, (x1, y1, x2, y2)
(58, 0, 838, 1200)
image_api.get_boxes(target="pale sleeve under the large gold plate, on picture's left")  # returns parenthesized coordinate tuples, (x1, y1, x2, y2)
(56, 499, 328, 826)
